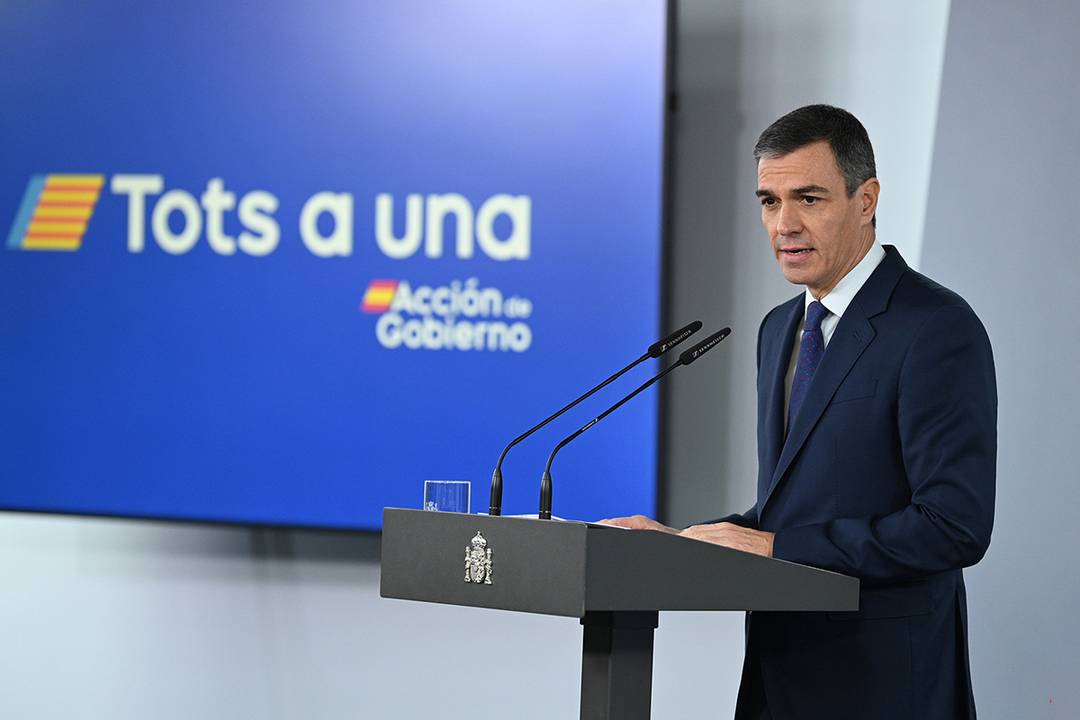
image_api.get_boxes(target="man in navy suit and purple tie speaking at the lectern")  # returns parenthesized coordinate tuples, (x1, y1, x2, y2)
(609, 105, 997, 720)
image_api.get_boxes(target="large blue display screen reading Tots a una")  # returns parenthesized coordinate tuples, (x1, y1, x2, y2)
(0, 0, 666, 529)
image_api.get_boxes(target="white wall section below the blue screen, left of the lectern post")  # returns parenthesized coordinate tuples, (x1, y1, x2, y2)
(0, 515, 581, 719)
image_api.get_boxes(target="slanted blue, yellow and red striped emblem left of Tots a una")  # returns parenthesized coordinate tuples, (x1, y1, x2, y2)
(8, 175, 105, 252)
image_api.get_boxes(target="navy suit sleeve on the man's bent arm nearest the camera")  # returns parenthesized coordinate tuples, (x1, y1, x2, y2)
(773, 305, 997, 584)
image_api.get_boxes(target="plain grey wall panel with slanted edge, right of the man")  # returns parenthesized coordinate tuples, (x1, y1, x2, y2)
(923, 0, 1080, 720)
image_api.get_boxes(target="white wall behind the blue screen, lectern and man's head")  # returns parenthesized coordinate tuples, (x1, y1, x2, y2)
(0, 0, 947, 720)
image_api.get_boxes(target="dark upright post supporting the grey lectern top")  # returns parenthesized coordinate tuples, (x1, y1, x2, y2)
(581, 611, 660, 720)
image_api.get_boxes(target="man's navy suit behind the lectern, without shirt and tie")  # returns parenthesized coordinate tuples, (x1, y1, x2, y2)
(725, 246, 997, 720)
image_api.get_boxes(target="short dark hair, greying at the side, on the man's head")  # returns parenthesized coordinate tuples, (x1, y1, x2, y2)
(754, 105, 877, 198)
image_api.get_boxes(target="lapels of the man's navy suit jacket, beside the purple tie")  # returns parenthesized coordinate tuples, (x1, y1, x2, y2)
(757, 245, 907, 519)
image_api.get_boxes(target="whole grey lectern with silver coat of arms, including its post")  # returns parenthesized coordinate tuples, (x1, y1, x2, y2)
(380, 507, 859, 720)
